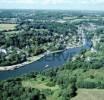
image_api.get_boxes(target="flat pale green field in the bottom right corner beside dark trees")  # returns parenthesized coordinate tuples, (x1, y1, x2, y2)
(71, 89, 104, 100)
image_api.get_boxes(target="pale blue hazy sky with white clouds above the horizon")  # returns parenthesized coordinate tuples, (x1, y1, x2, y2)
(0, 0, 104, 10)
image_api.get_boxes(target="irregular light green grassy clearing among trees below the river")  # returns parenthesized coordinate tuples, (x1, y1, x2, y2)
(22, 76, 62, 100)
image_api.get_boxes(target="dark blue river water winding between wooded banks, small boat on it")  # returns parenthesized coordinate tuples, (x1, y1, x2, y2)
(0, 40, 91, 80)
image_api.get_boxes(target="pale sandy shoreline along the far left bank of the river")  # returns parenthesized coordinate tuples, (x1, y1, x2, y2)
(0, 46, 81, 72)
